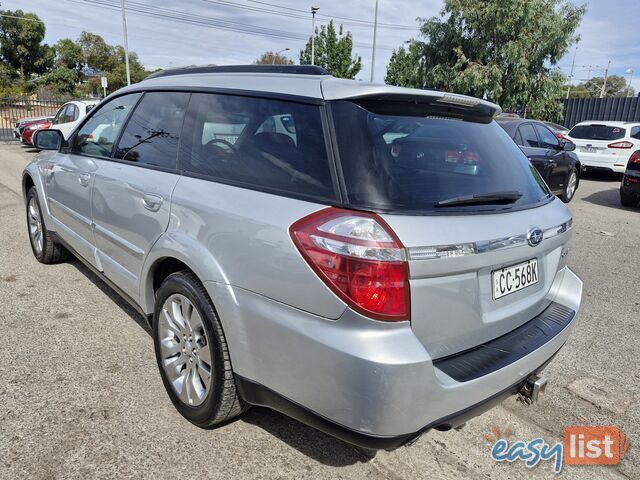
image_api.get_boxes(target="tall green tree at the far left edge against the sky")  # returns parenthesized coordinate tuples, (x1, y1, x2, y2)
(0, 10, 54, 80)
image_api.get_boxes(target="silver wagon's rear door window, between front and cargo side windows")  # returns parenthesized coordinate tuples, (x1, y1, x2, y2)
(114, 92, 190, 170)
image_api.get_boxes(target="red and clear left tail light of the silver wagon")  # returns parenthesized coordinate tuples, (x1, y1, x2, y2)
(289, 208, 410, 322)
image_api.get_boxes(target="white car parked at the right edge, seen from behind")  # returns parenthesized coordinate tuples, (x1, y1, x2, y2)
(566, 120, 640, 173)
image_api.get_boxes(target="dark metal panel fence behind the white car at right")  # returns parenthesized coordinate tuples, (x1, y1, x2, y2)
(563, 97, 640, 128)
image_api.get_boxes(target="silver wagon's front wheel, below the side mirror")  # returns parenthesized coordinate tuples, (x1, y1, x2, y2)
(26, 187, 71, 264)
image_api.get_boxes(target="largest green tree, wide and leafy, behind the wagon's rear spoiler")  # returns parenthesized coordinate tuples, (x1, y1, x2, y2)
(389, 0, 586, 120)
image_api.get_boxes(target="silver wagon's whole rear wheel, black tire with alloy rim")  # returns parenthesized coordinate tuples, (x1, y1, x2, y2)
(153, 271, 248, 428)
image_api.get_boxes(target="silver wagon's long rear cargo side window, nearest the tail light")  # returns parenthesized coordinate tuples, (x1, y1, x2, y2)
(180, 93, 336, 201)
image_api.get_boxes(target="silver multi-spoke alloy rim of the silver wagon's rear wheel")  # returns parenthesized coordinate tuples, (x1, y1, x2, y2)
(158, 293, 212, 406)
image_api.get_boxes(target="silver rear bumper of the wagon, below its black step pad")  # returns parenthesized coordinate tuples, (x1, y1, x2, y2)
(205, 268, 582, 442)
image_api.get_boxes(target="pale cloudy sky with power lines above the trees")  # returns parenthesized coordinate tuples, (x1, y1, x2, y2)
(2, 0, 640, 92)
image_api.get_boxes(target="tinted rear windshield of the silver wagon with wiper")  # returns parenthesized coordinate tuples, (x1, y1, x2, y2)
(332, 101, 550, 214)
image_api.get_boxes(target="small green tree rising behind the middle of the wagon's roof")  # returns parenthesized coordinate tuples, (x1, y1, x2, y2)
(300, 20, 362, 78)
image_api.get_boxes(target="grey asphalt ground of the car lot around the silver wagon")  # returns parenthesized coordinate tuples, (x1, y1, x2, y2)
(0, 145, 640, 479)
